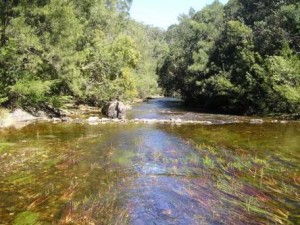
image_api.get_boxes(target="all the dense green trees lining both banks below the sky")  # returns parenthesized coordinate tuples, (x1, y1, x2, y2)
(0, 0, 300, 114)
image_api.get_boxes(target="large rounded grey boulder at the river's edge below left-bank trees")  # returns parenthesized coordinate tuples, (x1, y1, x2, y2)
(102, 101, 126, 119)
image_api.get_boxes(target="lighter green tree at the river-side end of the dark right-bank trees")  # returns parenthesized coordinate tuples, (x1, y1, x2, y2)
(158, 2, 223, 100)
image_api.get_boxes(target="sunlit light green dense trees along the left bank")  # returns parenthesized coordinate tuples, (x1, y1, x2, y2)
(0, 0, 167, 108)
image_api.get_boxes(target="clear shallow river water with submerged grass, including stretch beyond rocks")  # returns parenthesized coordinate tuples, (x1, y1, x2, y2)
(0, 99, 300, 225)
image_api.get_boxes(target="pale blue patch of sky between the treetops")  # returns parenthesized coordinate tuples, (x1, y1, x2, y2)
(130, 0, 228, 29)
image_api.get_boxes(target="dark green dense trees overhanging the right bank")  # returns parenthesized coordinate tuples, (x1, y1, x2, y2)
(158, 0, 300, 114)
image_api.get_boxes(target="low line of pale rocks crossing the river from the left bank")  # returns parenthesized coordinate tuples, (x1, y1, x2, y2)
(0, 106, 292, 129)
